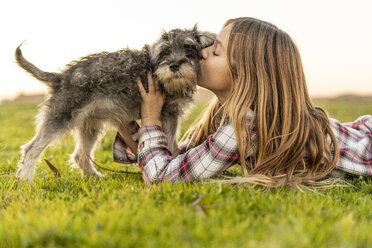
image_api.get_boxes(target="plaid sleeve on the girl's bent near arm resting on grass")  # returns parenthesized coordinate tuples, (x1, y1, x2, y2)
(138, 109, 256, 183)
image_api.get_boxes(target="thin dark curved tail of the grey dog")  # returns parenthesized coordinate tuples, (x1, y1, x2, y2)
(15, 42, 62, 86)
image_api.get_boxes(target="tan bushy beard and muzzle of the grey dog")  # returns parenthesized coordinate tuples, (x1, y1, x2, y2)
(155, 63, 198, 95)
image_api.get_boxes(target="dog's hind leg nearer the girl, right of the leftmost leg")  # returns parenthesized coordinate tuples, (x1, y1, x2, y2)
(71, 119, 103, 177)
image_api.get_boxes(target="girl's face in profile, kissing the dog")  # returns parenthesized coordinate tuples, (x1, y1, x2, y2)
(198, 25, 232, 103)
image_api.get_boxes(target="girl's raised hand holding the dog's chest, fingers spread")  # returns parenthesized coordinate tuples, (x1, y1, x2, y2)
(137, 72, 165, 127)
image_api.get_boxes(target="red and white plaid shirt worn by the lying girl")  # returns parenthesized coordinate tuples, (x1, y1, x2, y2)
(113, 110, 372, 183)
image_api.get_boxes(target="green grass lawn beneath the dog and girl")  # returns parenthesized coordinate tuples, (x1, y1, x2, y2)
(0, 101, 372, 247)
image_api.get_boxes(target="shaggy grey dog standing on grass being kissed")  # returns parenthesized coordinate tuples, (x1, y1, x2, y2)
(15, 25, 216, 182)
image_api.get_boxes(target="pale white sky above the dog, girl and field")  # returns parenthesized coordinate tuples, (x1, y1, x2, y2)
(0, 0, 372, 99)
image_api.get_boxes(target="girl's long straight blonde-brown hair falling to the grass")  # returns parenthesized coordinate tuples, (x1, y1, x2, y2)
(183, 18, 339, 187)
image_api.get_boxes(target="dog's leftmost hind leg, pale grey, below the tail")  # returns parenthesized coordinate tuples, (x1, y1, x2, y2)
(16, 123, 63, 183)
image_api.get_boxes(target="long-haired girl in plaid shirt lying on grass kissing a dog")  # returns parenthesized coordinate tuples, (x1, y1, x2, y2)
(113, 18, 372, 187)
